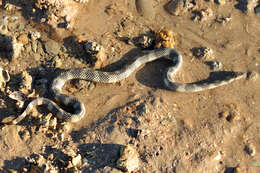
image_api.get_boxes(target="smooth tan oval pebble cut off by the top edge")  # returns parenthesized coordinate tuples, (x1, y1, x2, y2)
(135, 0, 155, 19)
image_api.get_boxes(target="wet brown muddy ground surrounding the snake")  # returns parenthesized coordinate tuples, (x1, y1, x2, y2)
(0, 0, 260, 173)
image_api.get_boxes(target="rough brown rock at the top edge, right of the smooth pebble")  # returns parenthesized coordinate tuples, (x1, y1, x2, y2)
(166, 0, 185, 16)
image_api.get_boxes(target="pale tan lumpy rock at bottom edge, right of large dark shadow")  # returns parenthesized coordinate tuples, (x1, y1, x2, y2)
(116, 145, 139, 172)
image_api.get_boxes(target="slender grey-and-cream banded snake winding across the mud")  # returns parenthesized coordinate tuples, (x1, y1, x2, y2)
(12, 48, 246, 124)
